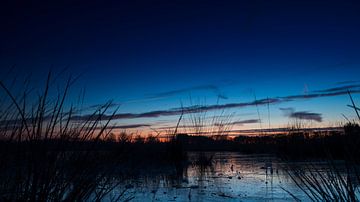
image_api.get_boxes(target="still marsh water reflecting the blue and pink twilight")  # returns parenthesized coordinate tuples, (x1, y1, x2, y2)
(106, 152, 358, 201)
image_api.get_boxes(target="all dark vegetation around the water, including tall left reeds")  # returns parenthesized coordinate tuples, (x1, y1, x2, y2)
(0, 74, 360, 201)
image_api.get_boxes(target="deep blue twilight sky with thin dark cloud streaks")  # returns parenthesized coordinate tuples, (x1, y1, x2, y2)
(0, 0, 360, 136)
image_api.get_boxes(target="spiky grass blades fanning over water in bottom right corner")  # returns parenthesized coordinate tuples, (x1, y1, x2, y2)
(289, 161, 360, 201)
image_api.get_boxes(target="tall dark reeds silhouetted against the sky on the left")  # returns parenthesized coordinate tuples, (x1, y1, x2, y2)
(0, 72, 131, 201)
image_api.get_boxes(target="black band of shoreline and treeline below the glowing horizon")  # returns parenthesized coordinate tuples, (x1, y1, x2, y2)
(0, 124, 360, 201)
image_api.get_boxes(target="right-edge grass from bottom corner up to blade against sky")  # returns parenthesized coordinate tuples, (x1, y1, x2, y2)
(288, 92, 360, 201)
